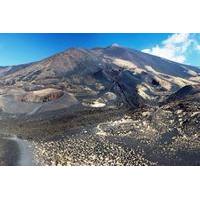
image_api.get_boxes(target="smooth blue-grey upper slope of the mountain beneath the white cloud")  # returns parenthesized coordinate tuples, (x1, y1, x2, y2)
(93, 46, 200, 78)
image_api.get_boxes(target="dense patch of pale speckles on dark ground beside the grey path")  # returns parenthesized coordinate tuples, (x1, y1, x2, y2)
(34, 134, 155, 166)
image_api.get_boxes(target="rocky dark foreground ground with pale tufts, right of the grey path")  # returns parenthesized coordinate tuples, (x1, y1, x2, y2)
(5, 95, 197, 166)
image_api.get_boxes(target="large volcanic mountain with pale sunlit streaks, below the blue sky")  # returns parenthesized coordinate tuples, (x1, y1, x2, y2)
(0, 46, 200, 116)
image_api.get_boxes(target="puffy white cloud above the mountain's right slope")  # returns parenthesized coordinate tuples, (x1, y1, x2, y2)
(142, 33, 193, 63)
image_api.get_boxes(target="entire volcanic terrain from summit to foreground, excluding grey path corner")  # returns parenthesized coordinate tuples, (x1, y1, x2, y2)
(0, 46, 200, 166)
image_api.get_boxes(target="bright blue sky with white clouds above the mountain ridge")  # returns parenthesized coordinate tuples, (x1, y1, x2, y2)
(0, 33, 200, 66)
